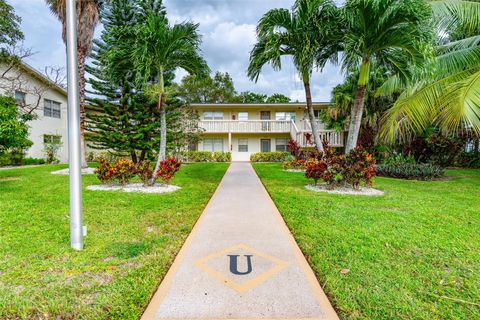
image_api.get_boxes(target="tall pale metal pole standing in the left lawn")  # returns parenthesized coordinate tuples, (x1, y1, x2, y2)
(66, 0, 83, 250)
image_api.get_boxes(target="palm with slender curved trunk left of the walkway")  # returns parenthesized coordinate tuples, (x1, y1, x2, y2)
(132, 11, 210, 184)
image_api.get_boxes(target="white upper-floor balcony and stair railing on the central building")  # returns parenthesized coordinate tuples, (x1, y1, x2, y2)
(199, 120, 344, 147)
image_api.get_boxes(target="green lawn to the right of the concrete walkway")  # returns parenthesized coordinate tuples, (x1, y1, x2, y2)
(254, 164, 480, 319)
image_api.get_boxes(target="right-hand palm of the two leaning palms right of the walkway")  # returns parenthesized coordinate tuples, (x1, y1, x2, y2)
(342, 0, 431, 152)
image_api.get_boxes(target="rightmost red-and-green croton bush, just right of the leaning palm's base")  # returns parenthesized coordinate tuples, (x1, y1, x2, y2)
(345, 147, 376, 189)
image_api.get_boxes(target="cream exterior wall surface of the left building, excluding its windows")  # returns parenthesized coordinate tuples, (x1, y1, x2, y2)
(0, 65, 68, 162)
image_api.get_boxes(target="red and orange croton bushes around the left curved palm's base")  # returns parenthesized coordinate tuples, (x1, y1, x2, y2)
(95, 158, 181, 186)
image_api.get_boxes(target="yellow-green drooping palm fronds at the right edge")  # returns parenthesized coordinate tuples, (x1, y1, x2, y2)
(379, 0, 480, 142)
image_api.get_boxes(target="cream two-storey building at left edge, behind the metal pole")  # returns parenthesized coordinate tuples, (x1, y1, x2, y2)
(0, 63, 68, 162)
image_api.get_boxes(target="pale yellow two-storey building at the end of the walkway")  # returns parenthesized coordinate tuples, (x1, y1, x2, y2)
(191, 103, 345, 161)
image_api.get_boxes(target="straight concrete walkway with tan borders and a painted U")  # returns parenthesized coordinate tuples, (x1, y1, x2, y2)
(142, 163, 338, 320)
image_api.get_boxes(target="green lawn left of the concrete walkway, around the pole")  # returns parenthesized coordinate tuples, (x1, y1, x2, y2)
(0, 163, 228, 319)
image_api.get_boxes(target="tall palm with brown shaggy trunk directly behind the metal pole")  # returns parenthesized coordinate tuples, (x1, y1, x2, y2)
(46, 0, 101, 168)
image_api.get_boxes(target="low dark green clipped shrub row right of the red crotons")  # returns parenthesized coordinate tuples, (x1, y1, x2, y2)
(376, 163, 445, 180)
